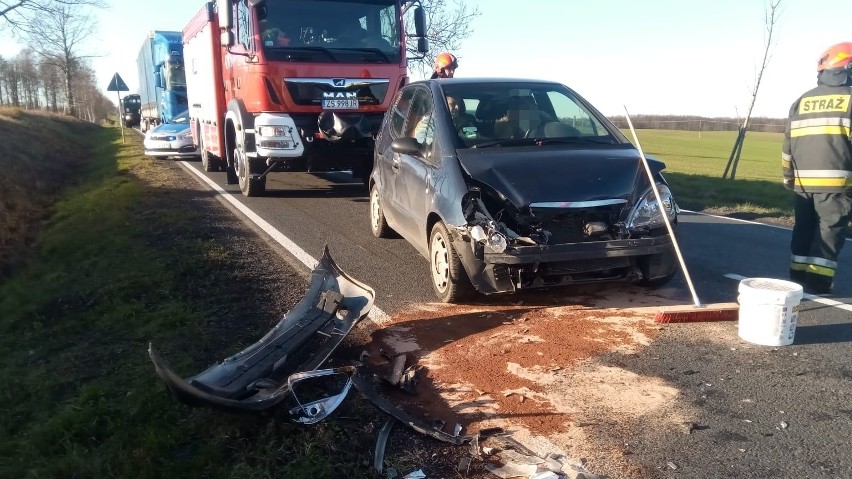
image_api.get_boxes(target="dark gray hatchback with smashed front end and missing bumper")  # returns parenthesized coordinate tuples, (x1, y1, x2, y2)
(369, 78, 678, 302)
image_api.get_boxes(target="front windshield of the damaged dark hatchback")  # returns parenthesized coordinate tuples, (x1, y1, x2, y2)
(442, 82, 627, 148)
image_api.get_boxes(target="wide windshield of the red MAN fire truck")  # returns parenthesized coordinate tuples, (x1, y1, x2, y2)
(259, 0, 402, 63)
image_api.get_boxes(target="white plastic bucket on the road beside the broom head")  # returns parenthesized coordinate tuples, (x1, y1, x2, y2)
(738, 278, 804, 346)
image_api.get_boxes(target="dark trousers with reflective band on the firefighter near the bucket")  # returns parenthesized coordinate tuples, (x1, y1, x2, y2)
(790, 192, 852, 294)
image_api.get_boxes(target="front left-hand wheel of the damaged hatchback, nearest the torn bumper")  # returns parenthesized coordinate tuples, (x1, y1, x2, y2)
(429, 221, 473, 303)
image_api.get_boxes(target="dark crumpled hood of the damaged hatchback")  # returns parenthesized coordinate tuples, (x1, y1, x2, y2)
(457, 147, 665, 207)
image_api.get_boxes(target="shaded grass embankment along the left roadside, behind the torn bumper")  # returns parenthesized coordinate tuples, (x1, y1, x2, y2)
(0, 111, 374, 478)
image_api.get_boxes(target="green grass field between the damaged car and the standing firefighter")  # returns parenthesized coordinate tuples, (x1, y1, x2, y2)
(626, 130, 793, 218)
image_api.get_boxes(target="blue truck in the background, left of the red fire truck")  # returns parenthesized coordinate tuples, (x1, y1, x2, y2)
(137, 30, 188, 131)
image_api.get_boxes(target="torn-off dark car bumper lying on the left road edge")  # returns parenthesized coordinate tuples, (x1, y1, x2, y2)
(148, 247, 375, 416)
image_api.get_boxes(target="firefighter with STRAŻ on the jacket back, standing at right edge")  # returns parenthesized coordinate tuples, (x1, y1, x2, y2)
(781, 42, 852, 294)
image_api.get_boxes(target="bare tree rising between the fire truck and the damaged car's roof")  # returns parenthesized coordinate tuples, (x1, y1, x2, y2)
(405, 0, 482, 75)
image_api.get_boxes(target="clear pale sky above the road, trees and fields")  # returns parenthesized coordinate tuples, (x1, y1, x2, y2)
(0, 0, 852, 118)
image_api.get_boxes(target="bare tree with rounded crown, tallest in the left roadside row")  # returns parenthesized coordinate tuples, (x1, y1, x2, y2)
(18, 5, 95, 116)
